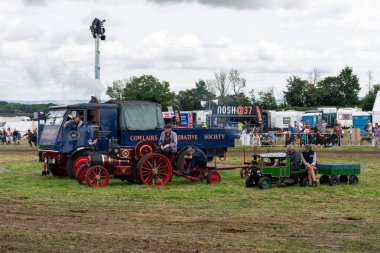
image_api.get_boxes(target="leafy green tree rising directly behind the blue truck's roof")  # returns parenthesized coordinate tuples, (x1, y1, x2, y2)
(106, 75, 175, 110)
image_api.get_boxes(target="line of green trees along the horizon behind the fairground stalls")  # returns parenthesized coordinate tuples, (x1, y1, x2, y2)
(106, 66, 380, 111)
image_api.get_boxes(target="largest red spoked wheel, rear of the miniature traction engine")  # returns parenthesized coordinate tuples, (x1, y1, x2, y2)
(137, 153, 172, 186)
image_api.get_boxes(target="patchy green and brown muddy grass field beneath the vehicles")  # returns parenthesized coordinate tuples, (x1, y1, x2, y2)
(0, 146, 380, 252)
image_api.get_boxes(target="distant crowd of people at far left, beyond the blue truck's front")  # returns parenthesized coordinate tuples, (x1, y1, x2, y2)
(0, 127, 38, 147)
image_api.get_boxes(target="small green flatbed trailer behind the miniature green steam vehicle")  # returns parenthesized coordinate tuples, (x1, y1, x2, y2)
(318, 163, 360, 186)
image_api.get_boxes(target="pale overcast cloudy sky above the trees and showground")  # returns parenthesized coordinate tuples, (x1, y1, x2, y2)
(0, 0, 380, 101)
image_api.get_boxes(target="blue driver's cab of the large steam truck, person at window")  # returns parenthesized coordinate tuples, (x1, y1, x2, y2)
(40, 104, 117, 153)
